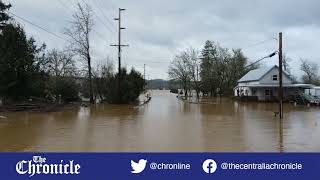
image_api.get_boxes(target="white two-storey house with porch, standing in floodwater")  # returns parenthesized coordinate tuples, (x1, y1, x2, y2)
(234, 65, 314, 101)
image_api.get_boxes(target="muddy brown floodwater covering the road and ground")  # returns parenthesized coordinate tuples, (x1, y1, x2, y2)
(0, 91, 320, 152)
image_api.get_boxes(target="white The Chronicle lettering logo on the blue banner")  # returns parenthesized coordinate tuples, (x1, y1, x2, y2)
(16, 156, 81, 177)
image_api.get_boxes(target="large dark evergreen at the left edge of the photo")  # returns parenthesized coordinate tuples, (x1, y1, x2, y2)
(0, 24, 46, 101)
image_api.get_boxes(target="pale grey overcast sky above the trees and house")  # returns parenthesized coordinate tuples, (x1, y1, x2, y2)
(5, 0, 320, 79)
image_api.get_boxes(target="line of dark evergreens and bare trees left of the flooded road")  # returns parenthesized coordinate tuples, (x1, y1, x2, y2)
(0, 1, 144, 103)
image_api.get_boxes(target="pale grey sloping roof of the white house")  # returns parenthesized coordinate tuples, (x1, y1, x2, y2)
(238, 65, 289, 82)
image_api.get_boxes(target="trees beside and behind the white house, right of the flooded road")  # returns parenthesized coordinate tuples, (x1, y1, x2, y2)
(168, 40, 320, 99)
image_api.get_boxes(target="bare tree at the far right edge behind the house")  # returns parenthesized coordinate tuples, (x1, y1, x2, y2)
(300, 59, 319, 84)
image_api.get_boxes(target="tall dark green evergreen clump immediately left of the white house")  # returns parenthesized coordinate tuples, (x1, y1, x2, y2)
(200, 41, 251, 96)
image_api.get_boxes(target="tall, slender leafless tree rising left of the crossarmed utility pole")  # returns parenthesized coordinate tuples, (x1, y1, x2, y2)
(65, 3, 94, 104)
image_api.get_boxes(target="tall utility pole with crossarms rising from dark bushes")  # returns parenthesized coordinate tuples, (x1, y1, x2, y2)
(111, 8, 129, 102)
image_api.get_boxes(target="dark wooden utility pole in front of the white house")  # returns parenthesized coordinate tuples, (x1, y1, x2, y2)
(278, 32, 283, 119)
